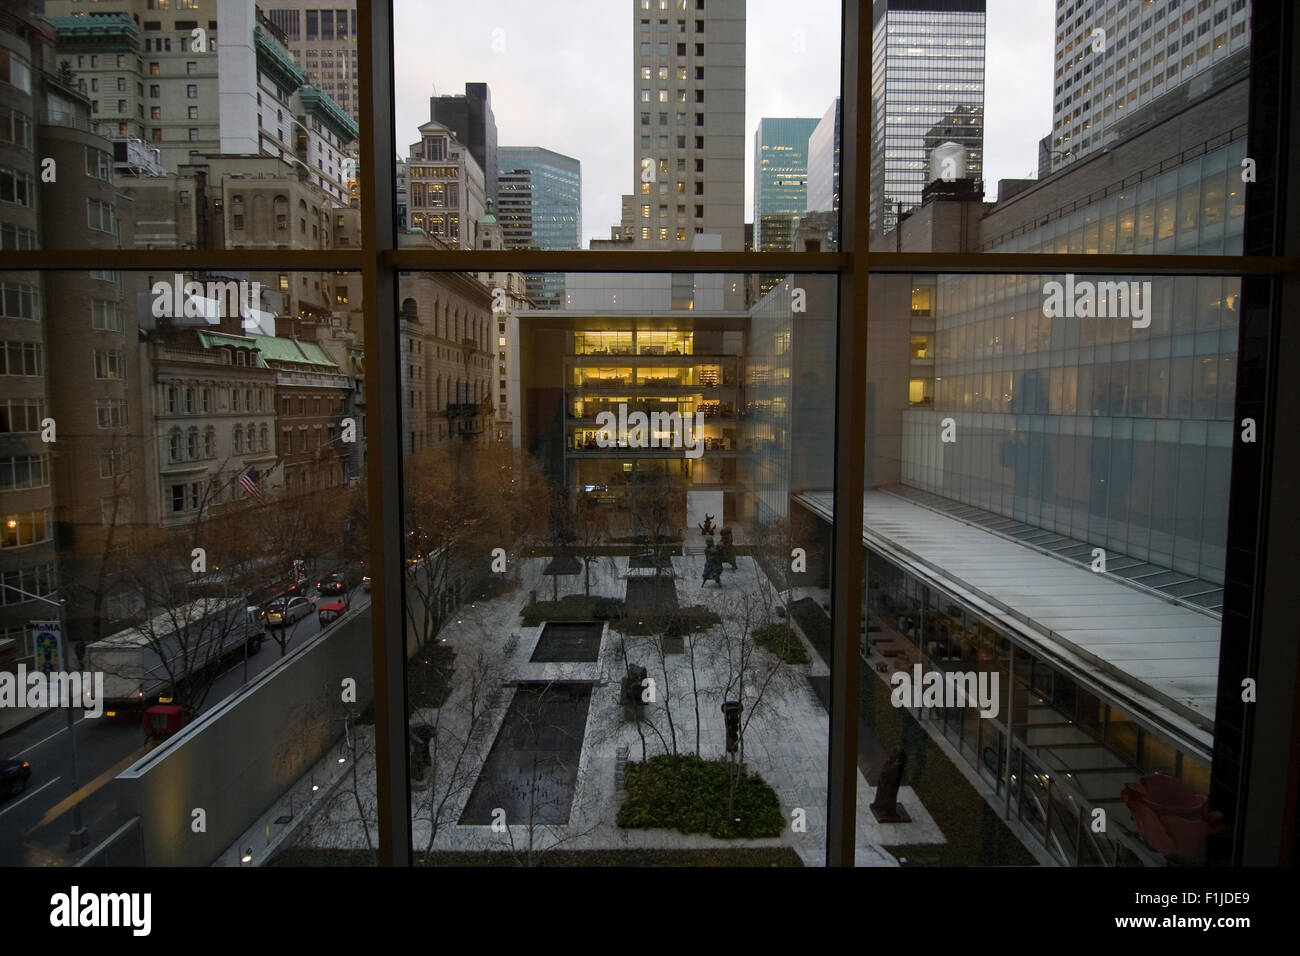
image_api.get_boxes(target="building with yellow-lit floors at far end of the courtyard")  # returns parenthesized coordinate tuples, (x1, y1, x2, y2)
(511, 274, 748, 531)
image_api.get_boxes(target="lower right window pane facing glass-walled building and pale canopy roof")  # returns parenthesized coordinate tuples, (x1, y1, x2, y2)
(858, 274, 1242, 866)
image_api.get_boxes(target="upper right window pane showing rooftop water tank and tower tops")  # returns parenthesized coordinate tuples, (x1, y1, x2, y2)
(868, 0, 1260, 255)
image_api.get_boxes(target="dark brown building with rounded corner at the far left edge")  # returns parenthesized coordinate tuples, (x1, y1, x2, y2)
(0, 1, 144, 686)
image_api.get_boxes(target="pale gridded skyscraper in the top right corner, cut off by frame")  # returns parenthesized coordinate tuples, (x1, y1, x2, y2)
(1050, 0, 1251, 169)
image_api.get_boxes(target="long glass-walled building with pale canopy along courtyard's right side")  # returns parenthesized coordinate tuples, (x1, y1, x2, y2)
(789, 57, 1248, 865)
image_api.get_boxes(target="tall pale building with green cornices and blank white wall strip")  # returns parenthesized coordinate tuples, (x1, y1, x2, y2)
(47, 0, 358, 204)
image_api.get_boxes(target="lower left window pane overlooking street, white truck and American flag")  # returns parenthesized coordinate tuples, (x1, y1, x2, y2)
(0, 269, 377, 866)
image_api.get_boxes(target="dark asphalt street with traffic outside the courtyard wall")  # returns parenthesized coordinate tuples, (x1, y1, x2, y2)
(0, 588, 371, 866)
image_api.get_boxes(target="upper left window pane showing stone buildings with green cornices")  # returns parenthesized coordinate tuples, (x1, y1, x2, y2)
(26, 0, 359, 251)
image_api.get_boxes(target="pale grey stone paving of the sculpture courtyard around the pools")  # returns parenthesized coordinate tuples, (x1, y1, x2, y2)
(287, 555, 944, 866)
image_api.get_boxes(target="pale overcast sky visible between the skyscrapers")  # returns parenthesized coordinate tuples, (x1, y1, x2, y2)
(394, 0, 1056, 245)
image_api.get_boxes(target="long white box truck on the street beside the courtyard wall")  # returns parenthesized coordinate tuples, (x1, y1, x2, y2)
(83, 597, 264, 717)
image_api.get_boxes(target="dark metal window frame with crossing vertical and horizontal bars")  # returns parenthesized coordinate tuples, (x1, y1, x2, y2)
(4, 0, 1300, 866)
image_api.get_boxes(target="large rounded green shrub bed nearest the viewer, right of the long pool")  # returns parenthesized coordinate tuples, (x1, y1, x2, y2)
(615, 753, 785, 840)
